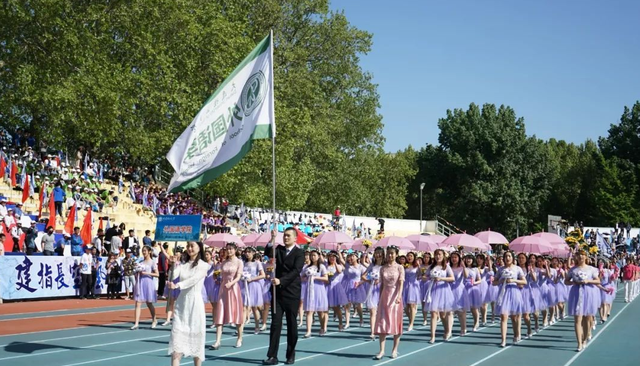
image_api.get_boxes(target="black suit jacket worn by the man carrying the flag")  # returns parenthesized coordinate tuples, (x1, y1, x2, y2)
(276, 245, 304, 303)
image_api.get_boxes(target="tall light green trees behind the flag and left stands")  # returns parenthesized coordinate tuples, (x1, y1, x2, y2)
(0, 0, 414, 217)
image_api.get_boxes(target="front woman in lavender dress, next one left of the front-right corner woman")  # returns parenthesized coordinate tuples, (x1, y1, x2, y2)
(493, 251, 527, 347)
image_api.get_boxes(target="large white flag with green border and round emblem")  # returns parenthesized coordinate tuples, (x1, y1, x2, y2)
(167, 35, 276, 192)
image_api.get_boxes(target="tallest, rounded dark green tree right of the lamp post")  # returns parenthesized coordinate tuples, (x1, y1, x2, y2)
(408, 104, 549, 234)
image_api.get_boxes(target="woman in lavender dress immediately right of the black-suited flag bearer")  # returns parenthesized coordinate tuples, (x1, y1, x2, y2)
(302, 250, 329, 338)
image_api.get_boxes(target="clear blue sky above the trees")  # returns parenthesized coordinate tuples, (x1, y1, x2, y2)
(331, 0, 640, 151)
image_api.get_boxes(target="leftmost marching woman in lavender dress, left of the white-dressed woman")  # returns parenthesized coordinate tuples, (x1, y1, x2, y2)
(131, 246, 158, 330)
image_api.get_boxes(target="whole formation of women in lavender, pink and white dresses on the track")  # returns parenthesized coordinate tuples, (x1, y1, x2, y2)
(127, 243, 640, 365)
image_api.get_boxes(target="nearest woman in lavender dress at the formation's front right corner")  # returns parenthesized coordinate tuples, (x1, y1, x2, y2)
(565, 250, 600, 352)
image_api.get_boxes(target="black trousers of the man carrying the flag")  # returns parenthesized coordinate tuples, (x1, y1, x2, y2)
(267, 298, 300, 360)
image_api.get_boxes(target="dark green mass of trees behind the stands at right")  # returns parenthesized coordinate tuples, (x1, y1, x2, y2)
(407, 103, 640, 237)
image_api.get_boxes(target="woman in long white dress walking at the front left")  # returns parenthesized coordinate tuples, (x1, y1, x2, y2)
(169, 241, 210, 366)
